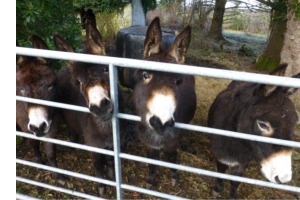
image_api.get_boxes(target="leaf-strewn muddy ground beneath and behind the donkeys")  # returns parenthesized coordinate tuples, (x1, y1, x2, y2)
(16, 30, 300, 199)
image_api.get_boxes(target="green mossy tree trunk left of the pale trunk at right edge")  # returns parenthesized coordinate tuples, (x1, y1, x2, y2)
(256, 10, 286, 71)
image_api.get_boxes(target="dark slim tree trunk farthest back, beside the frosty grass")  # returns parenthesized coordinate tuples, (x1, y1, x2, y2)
(208, 0, 227, 40)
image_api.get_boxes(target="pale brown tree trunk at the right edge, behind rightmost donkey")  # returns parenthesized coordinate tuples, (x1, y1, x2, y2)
(281, 1, 300, 114)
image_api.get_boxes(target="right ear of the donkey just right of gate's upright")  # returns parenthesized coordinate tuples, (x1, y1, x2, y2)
(168, 25, 192, 64)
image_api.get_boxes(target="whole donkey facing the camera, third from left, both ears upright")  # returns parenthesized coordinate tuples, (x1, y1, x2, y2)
(133, 17, 196, 188)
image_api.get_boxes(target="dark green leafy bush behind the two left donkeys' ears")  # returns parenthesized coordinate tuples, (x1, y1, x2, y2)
(16, 0, 81, 49)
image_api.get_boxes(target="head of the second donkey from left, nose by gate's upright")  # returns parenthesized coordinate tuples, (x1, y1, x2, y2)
(54, 21, 113, 120)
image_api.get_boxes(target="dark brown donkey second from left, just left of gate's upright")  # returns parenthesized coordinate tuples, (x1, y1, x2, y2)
(54, 21, 122, 195)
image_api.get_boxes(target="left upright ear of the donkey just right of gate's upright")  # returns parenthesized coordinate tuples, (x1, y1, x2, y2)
(144, 17, 162, 58)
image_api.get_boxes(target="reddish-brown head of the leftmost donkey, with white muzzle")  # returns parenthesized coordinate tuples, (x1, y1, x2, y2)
(16, 35, 56, 136)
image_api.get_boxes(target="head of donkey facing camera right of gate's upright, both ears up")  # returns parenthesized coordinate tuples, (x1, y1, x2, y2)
(134, 17, 191, 133)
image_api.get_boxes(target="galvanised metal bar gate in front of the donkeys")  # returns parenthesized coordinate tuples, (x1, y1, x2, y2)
(16, 47, 300, 199)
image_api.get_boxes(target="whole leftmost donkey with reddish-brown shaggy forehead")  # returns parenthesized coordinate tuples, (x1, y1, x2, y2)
(16, 35, 65, 184)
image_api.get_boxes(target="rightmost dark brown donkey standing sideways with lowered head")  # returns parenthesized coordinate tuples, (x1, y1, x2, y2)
(208, 64, 300, 198)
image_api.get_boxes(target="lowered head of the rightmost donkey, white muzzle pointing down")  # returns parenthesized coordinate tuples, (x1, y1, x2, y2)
(237, 64, 300, 183)
